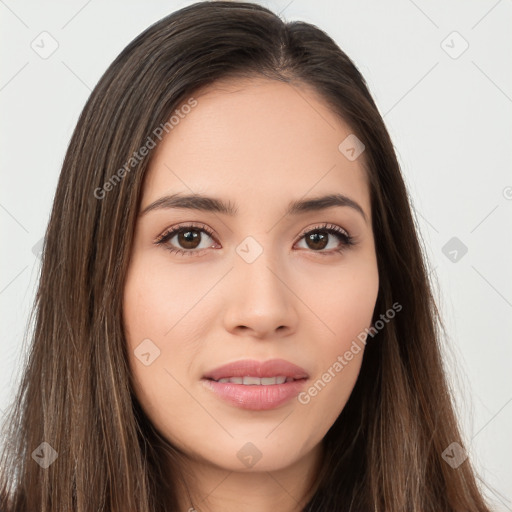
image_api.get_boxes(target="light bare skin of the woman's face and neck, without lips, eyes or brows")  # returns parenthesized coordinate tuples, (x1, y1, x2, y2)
(123, 79, 379, 512)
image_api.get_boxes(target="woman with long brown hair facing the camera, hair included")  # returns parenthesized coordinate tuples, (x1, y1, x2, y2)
(0, 2, 489, 512)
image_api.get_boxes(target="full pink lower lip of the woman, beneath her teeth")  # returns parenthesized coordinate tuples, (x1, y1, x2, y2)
(203, 379, 306, 411)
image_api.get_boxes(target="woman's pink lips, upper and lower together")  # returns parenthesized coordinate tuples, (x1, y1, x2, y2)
(203, 359, 309, 411)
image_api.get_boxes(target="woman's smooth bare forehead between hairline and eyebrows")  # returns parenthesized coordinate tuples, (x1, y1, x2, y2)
(144, 79, 370, 213)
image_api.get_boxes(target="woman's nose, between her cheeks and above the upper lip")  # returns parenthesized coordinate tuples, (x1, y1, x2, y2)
(224, 251, 300, 339)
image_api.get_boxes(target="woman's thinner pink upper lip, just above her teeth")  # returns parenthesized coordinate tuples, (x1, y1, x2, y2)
(203, 359, 309, 380)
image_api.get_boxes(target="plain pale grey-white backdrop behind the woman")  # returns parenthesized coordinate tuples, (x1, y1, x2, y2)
(0, 0, 512, 511)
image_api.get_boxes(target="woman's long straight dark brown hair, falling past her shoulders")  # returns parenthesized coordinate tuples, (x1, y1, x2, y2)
(0, 1, 489, 512)
